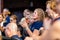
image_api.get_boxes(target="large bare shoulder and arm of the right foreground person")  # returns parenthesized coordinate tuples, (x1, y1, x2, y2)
(40, 20, 60, 40)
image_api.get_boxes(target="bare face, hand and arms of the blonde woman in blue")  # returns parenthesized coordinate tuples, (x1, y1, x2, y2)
(20, 10, 39, 37)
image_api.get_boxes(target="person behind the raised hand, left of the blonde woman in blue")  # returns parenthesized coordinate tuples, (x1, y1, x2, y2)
(19, 9, 32, 39)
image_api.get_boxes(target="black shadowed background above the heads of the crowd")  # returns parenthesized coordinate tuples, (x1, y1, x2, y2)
(1, 0, 47, 12)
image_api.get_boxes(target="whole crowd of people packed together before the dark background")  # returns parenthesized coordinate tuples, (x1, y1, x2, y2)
(0, 0, 60, 40)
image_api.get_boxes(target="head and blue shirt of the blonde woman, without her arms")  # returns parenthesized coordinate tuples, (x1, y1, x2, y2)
(31, 8, 45, 31)
